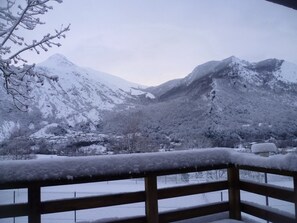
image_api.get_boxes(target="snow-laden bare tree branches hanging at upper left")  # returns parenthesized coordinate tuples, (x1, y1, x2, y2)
(0, 0, 69, 110)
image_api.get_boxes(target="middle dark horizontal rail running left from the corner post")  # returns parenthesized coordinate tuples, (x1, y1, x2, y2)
(0, 175, 228, 221)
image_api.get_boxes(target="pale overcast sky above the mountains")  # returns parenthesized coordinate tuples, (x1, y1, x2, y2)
(24, 0, 297, 85)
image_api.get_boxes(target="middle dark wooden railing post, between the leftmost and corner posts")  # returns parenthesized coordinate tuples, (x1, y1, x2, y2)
(145, 176, 159, 223)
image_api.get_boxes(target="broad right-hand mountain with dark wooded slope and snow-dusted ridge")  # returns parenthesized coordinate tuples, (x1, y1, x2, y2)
(138, 57, 297, 147)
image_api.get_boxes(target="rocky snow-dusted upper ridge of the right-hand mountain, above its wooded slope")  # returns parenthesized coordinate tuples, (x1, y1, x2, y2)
(148, 56, 297, 98)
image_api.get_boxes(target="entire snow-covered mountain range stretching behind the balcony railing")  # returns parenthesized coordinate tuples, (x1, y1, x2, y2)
(0, 55, 297, 151)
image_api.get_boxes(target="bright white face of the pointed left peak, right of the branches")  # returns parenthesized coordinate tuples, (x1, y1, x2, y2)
(33, 54, 153, 125)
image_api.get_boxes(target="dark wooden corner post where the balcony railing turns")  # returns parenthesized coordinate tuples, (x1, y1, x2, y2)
(228, 166, 241, 220)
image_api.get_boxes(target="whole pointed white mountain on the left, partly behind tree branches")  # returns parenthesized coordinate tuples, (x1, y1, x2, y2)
(0, 54, 153, 139)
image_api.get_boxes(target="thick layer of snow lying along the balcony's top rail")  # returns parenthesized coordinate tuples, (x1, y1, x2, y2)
(0, 148, 297, 187)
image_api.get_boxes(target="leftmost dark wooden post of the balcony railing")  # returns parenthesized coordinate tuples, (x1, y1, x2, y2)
(28, 186, 41, 223)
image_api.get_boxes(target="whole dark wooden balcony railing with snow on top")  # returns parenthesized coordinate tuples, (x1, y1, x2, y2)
(0, 148, 297, 223)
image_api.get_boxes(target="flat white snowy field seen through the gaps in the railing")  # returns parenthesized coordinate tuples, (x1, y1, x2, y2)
(0, 174, 294, 223)
